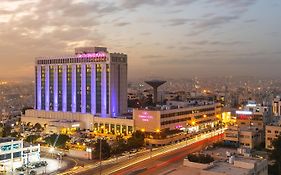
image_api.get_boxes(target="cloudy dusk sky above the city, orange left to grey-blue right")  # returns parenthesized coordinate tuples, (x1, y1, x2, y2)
(0, 0, 281, 80)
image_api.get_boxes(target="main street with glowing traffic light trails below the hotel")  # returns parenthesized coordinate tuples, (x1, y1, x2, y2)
(62, 129, 223, 175)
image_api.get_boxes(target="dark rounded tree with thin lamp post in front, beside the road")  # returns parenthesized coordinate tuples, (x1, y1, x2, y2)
(94, 139, 111, 160)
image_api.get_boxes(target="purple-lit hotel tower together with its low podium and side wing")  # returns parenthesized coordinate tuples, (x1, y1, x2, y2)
(21, 47, 221, 139)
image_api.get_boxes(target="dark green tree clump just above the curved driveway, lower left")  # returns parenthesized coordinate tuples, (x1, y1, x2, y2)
(45, 134, 70, 148)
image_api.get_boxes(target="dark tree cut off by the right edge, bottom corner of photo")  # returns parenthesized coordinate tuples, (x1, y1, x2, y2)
(269, 135, 281, 174)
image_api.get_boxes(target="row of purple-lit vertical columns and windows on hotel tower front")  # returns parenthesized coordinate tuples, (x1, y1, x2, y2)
(36, 64, 107, 116)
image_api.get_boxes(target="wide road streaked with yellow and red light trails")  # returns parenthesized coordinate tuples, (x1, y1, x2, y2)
(61, 129, 223, 175)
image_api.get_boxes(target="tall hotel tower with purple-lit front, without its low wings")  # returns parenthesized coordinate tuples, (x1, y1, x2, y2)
(35, 47, 127, 117)
